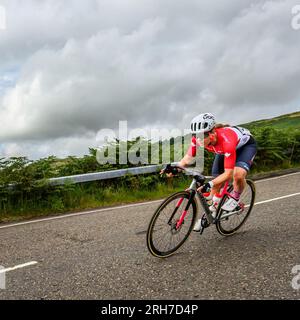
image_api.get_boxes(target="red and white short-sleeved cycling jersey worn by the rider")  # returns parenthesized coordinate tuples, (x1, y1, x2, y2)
(188, 127, 251, 169)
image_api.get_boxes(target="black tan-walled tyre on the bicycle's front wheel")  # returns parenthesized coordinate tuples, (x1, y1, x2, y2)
(146, 191, 197, 258)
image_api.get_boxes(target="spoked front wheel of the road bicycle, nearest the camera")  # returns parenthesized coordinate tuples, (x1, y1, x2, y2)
(147, 191, 197, 258)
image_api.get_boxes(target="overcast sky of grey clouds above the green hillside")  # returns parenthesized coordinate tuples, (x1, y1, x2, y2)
(0, 0, 300, 159)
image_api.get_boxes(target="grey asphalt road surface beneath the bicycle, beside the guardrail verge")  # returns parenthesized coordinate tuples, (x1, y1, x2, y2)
(0, 173, 300, 299)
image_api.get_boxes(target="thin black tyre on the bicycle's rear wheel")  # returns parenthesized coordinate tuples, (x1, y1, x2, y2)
(216, 179, 256, 236)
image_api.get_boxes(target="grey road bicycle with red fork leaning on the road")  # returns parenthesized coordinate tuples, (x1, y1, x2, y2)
(147, 165, 256, 258)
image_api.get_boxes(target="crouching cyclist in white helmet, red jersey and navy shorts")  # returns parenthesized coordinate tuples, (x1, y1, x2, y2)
(164, 113, 257, 231)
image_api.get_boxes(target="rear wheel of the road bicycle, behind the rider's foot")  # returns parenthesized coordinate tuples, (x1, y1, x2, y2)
(216, 180, 255, 236)
